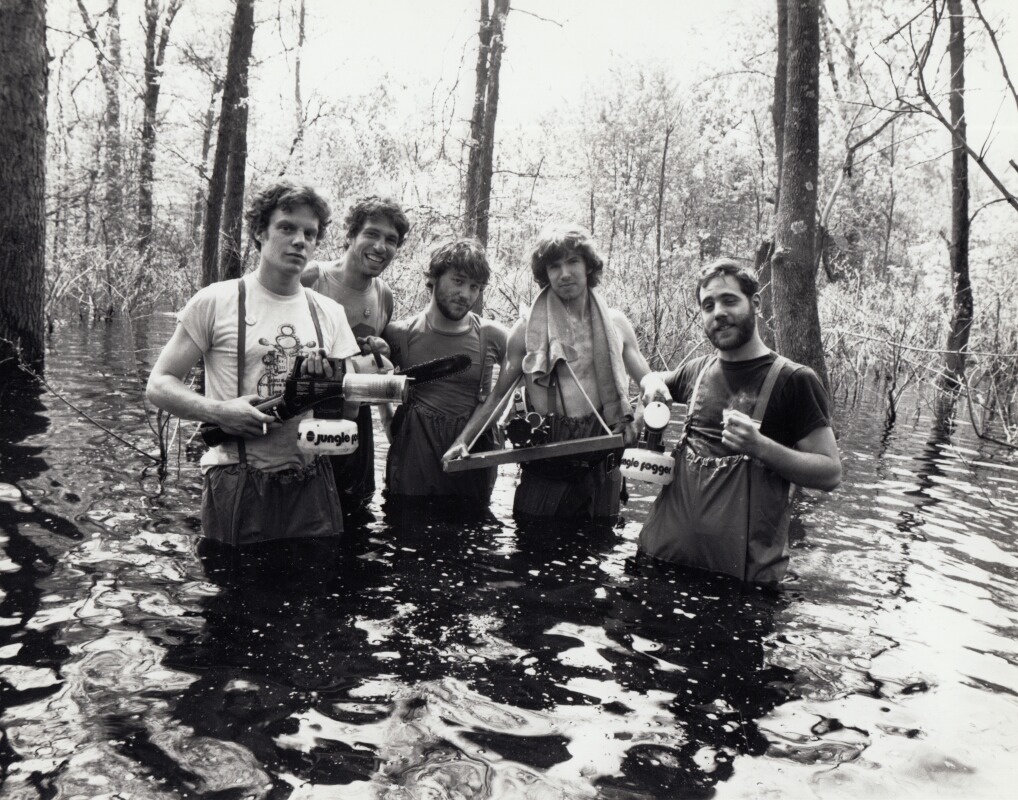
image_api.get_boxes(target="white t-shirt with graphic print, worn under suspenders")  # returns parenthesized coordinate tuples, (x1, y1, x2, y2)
(177, 273, 360, 472)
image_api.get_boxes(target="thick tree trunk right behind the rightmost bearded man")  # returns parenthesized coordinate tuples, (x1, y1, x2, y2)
(771, 0, 828, 387)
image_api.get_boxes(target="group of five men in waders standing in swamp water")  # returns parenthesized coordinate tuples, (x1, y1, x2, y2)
(149, 182, 841, 582)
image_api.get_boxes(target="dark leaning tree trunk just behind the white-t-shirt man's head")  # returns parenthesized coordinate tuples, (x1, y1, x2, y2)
(202, 0, 255, 286)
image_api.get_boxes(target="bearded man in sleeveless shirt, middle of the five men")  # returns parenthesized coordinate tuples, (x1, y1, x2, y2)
(385, 239, 506, 498)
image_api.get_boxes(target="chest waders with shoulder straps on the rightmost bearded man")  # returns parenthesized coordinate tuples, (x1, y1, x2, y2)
(639, 355, 799, 583)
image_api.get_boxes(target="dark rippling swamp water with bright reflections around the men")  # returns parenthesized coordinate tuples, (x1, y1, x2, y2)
(0, 318, 1018, 800)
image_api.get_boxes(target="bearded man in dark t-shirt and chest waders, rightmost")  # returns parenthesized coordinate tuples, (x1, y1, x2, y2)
(639, 259, 841, 583)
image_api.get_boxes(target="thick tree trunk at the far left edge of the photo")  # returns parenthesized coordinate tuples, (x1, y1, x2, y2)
(0, 0, 47, 376)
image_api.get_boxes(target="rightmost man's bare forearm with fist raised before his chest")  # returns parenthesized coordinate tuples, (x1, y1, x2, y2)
(721, 411, 841, 492)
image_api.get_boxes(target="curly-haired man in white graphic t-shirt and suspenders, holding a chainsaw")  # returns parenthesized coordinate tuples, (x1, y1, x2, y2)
(147, 181, 386, 546)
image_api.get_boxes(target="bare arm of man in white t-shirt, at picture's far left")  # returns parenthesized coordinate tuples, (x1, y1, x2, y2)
(145, 325, 279, 437)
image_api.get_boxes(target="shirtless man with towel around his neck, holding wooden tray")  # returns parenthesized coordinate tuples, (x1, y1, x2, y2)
(443, 226, 651, 519)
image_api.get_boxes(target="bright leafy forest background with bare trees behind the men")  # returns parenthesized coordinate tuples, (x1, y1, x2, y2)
(0, 0, 1018, 442)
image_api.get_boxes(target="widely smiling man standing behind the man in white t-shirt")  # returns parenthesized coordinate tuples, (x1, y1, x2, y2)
(300, 195, 410, 512)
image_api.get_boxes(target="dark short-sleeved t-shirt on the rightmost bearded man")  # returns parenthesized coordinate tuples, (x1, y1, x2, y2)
(665, 353, 831, 456)
